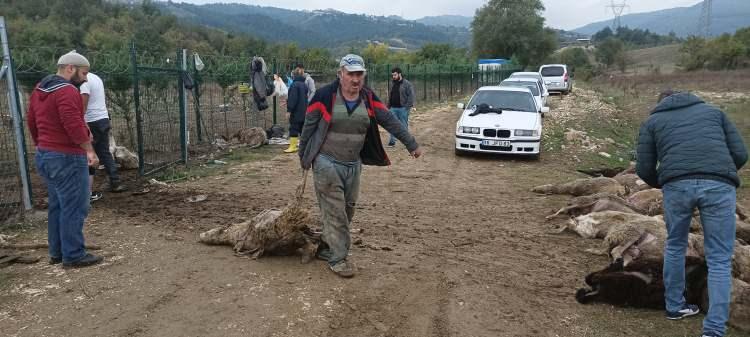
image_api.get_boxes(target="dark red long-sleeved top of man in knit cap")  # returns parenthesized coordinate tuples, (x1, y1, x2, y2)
(26, 75, 91, 154)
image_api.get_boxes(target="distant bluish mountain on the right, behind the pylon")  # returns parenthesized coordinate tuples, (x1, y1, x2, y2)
(573, 0, 750, 37)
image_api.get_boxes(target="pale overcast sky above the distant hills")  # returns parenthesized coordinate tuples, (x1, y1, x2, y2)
(181, 0, 701, 29)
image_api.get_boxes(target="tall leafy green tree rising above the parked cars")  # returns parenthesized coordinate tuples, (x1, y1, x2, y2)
(471, 0, 557, 67)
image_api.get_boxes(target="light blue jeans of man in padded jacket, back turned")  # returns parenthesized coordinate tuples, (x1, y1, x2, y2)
(663, 179, 737, 336)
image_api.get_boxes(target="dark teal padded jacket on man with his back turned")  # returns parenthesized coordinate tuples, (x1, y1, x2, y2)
(636, 93, 747, 188)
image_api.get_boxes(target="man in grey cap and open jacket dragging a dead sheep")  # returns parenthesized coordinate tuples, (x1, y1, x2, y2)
(299, 54, 422, 277)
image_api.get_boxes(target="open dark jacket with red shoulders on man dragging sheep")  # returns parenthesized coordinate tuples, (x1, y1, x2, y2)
(299, 80, 419, 169)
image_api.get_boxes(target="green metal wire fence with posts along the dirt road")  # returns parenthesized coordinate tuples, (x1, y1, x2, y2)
(0, 35, 516, 218)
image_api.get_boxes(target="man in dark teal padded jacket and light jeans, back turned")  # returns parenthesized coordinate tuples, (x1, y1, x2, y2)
(636, 91, 748, 337)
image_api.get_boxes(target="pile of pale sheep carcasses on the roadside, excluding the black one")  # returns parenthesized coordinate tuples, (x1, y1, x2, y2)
(532, 168, 750, 330)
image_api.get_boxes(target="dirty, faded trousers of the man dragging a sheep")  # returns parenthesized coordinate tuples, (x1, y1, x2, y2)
(313, 154, 362, 266)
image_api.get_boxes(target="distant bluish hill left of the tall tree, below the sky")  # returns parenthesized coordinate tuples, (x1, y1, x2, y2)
(157, 2, 471, 49)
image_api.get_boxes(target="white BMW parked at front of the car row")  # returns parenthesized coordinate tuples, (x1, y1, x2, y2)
(456, 86, 549, 159)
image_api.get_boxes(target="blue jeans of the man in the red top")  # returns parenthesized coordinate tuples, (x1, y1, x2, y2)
(35, 149, 89, 263)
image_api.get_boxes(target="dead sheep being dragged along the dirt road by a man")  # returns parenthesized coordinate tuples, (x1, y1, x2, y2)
(199, 207, 319, 263)
